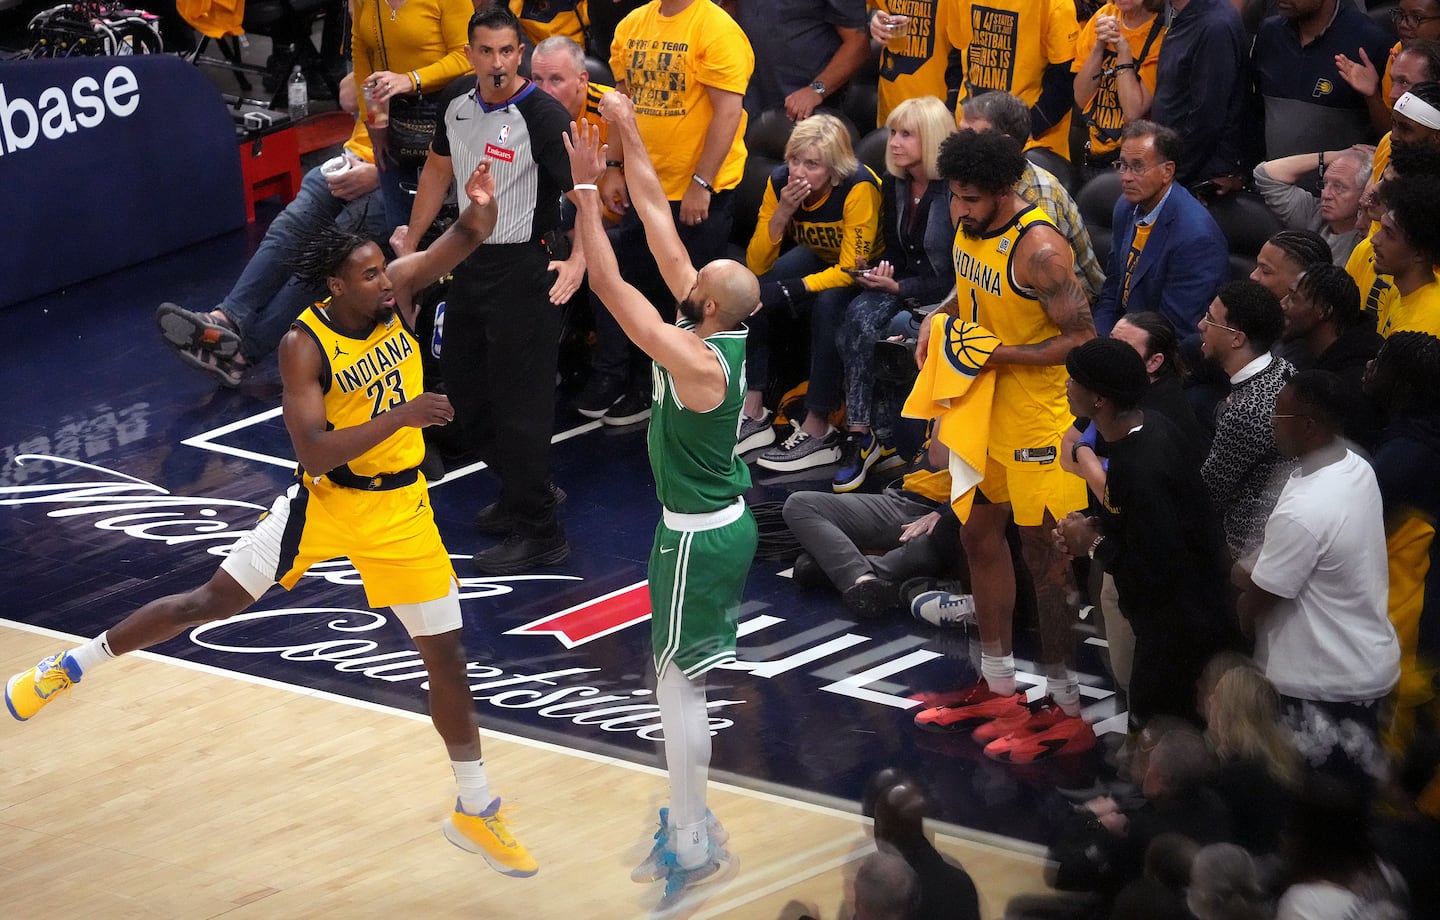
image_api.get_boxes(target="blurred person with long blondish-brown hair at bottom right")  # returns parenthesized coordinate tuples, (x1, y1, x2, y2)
(1202, 657, 1305, 854)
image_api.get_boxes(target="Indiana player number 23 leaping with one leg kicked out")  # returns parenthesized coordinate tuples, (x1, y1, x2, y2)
(4, 163, 537, 875)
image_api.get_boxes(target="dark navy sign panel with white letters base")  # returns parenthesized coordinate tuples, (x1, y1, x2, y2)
(0, 55, 245, 307)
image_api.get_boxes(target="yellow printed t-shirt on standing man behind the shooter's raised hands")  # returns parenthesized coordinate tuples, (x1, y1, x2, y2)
(611, 0, 755, 202)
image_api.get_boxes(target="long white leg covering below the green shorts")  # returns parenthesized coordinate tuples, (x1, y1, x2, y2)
(655, 664, 710, 868)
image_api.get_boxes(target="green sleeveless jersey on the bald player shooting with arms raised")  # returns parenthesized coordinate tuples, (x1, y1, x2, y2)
(649, 321, 750, 514)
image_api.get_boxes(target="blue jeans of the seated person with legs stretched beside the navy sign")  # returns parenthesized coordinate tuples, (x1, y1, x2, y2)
(219, 167, 384, 364)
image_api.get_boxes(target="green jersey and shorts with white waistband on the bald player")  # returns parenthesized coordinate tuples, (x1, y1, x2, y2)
(649, 321, 757, 677)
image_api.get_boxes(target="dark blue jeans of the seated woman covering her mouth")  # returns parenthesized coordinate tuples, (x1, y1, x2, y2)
(744, 246, 855, 416)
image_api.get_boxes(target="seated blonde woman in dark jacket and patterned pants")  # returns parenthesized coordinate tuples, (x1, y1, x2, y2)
(834, 96, 955, 492)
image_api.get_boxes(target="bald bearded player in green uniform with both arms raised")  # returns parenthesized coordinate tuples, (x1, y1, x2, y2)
(566, 92, 760, 914)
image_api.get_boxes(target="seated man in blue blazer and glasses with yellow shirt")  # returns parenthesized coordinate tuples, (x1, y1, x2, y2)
(1094, 121, 1230, 335)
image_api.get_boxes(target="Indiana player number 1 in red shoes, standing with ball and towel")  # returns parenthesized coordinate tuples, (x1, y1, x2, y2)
(916, 131, 1094, 763)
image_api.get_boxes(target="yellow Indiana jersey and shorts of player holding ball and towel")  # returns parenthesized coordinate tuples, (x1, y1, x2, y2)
(953, 204, 1073, 469)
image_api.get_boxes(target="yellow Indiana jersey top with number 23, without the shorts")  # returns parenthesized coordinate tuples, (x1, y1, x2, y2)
(295, 304, 425, 477)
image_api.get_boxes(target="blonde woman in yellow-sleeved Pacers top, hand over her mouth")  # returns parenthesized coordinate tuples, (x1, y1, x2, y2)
(740, 115, 880, 472)
